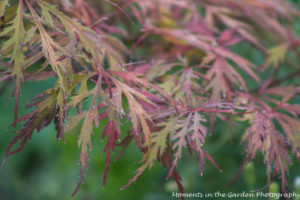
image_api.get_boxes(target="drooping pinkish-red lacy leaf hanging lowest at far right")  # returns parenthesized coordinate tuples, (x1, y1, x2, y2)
(243, 111, 291, 190)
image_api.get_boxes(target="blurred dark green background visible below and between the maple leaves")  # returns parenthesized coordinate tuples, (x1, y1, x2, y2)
(0, 0, 300, 200)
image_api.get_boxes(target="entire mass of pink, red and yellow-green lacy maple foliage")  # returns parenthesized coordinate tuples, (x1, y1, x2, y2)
(0, 0, 300, 196)
